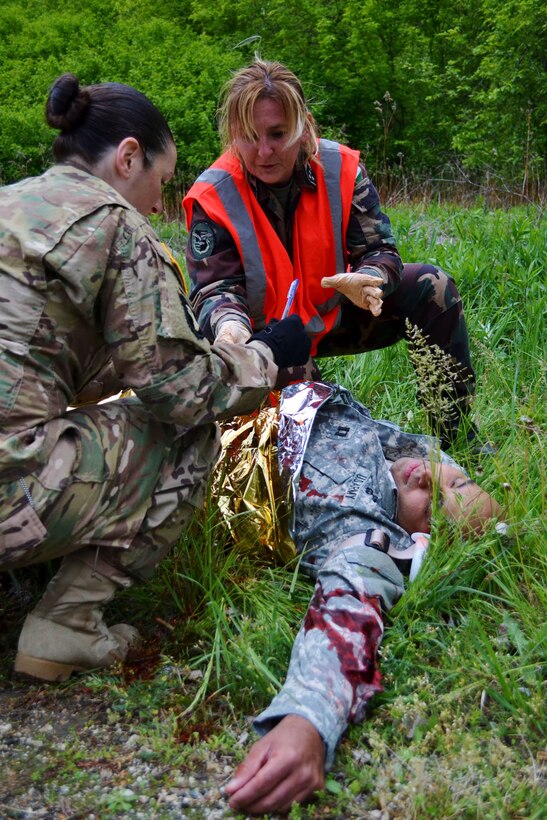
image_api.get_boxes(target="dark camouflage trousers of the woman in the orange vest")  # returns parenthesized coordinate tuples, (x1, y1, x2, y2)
(277, 264, 475, 444)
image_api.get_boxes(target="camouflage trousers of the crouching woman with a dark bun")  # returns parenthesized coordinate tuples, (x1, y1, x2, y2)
(0, 399, 220, 578)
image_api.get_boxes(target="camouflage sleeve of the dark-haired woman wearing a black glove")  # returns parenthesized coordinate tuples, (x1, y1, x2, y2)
(72, 210, 277, 428)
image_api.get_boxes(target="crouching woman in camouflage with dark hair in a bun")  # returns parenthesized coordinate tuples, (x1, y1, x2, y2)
(0, 74, 310, 680)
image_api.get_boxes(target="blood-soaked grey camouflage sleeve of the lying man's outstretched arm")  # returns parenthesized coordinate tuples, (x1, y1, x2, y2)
(254, 547, 403, 768)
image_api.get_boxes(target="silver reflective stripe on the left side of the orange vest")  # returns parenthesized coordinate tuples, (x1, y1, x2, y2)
(197, 168, 266, 327)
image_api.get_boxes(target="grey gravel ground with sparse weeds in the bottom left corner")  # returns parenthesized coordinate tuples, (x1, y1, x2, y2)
(0, 685, 244, 820)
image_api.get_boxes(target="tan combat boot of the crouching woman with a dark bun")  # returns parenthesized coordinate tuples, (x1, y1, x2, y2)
(15, 555, 139, 681)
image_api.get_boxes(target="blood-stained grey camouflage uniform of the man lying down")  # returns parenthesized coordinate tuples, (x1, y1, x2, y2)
(255, 383, 460, 767)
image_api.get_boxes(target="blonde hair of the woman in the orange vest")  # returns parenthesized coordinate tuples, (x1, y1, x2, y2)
(218, 57, 317, 160)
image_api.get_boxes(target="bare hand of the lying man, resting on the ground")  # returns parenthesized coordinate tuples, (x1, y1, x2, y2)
(226, 715, 325, 814)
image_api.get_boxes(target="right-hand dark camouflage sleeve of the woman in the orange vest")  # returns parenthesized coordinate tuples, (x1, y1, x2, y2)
(346, 165, 403, 298)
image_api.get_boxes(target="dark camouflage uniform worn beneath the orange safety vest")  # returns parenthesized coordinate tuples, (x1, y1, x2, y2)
(187, 163, 475, 438)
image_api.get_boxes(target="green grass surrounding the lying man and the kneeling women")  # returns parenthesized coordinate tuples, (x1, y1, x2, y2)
(2, 205, 547, 818)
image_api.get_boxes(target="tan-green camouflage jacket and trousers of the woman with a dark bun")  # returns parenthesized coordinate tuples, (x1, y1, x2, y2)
(0, 164, 277, 577)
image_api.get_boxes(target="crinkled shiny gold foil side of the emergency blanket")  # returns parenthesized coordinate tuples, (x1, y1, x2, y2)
(214, 407, 296, 563)
